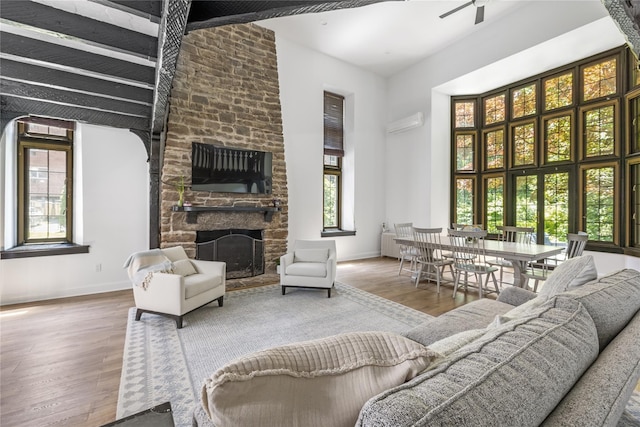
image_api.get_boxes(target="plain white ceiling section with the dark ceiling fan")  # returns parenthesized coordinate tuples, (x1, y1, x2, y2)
(258, 0, 528, 76)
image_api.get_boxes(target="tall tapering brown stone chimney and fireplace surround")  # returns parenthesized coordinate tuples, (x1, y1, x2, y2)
(160, 24, 288, 278)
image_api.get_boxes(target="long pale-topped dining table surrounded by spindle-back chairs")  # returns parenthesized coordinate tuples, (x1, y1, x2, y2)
(394, 235, 564, 288)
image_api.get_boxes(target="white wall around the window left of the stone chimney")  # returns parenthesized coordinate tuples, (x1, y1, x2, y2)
(0, 124, 149, 305)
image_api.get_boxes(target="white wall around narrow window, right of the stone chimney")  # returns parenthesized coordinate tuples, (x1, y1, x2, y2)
(276, 35, 387, 260)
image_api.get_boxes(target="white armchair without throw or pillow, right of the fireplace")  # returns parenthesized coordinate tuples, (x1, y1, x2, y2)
(280, 240, 337, 298)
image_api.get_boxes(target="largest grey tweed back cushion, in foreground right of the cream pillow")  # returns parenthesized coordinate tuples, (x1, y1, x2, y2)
(356, 297, 598, 427)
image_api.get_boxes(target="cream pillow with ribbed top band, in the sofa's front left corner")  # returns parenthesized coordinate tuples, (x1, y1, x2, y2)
(202, 332, 437, 427)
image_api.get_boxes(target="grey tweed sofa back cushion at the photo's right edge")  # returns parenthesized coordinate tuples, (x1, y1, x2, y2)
(559, 269, 640, 350)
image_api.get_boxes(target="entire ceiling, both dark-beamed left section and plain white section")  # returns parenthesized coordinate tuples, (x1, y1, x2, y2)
(0, 0, 640, 145)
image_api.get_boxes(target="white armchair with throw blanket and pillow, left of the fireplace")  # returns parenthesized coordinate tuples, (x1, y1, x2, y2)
(125, 246, 226, 329)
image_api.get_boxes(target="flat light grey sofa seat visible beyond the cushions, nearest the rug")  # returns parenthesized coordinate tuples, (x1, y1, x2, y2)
(404, 298, 513, 346)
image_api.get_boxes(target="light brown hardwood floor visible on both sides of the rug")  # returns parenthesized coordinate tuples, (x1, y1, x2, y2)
(0, 258, 524, 427)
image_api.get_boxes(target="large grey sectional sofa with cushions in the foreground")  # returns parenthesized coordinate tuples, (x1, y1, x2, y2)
(194, 255, 640, 427)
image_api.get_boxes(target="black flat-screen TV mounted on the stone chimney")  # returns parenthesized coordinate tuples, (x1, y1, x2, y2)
(191, 142, 273, 194)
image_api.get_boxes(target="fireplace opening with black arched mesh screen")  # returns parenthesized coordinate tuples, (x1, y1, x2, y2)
(196, 229, 265, 279)
